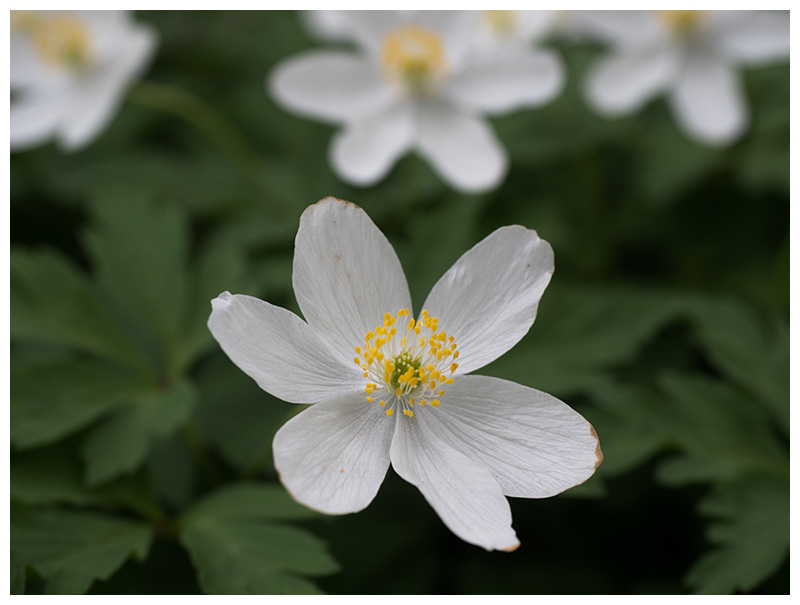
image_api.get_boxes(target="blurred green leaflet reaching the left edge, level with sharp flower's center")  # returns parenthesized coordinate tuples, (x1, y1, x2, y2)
(11, 358, 143, 448)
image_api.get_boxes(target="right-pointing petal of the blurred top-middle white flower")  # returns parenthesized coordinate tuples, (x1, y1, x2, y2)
(445, 47, 564, 114)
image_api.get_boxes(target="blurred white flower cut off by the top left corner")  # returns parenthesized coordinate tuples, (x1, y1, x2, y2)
(10, 11, 156, 151)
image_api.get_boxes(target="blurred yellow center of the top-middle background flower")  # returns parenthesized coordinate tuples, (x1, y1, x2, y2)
(382, 25, 447, 94)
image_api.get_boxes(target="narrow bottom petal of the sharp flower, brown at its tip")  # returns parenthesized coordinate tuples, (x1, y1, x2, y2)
(391, 408, 519, 551)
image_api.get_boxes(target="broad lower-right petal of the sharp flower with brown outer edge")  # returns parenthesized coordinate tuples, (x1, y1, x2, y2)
(422, 376, 603, 498)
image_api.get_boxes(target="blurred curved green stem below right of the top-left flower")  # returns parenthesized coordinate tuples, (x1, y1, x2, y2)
(128, 82, 261, 180)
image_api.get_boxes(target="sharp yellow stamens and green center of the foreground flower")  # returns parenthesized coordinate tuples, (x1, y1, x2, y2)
(353, 309, 458, 418)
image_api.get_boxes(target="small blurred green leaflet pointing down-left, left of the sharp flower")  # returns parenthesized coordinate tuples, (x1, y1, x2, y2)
(81, 382, 196, 485)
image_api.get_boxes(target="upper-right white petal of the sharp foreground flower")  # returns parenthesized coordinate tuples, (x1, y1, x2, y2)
(423, 225, 553, 374)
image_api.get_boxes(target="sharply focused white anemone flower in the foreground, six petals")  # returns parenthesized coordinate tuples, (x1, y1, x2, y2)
(208, 198, 602, 551)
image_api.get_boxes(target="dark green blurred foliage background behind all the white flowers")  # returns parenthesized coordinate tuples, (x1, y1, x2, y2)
(10, 11, 789, 594)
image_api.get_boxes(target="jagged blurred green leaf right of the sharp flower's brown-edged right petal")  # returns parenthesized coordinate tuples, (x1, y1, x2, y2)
(659, 374, 788, 485)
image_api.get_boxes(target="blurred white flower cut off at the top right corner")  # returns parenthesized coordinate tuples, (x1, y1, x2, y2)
(579, 10, 789, 145)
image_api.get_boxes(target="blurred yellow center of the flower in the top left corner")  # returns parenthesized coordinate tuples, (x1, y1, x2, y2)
(30, 15, 90, 69)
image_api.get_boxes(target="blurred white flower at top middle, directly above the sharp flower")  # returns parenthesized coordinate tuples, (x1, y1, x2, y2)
(268, 11, 563, 191)
